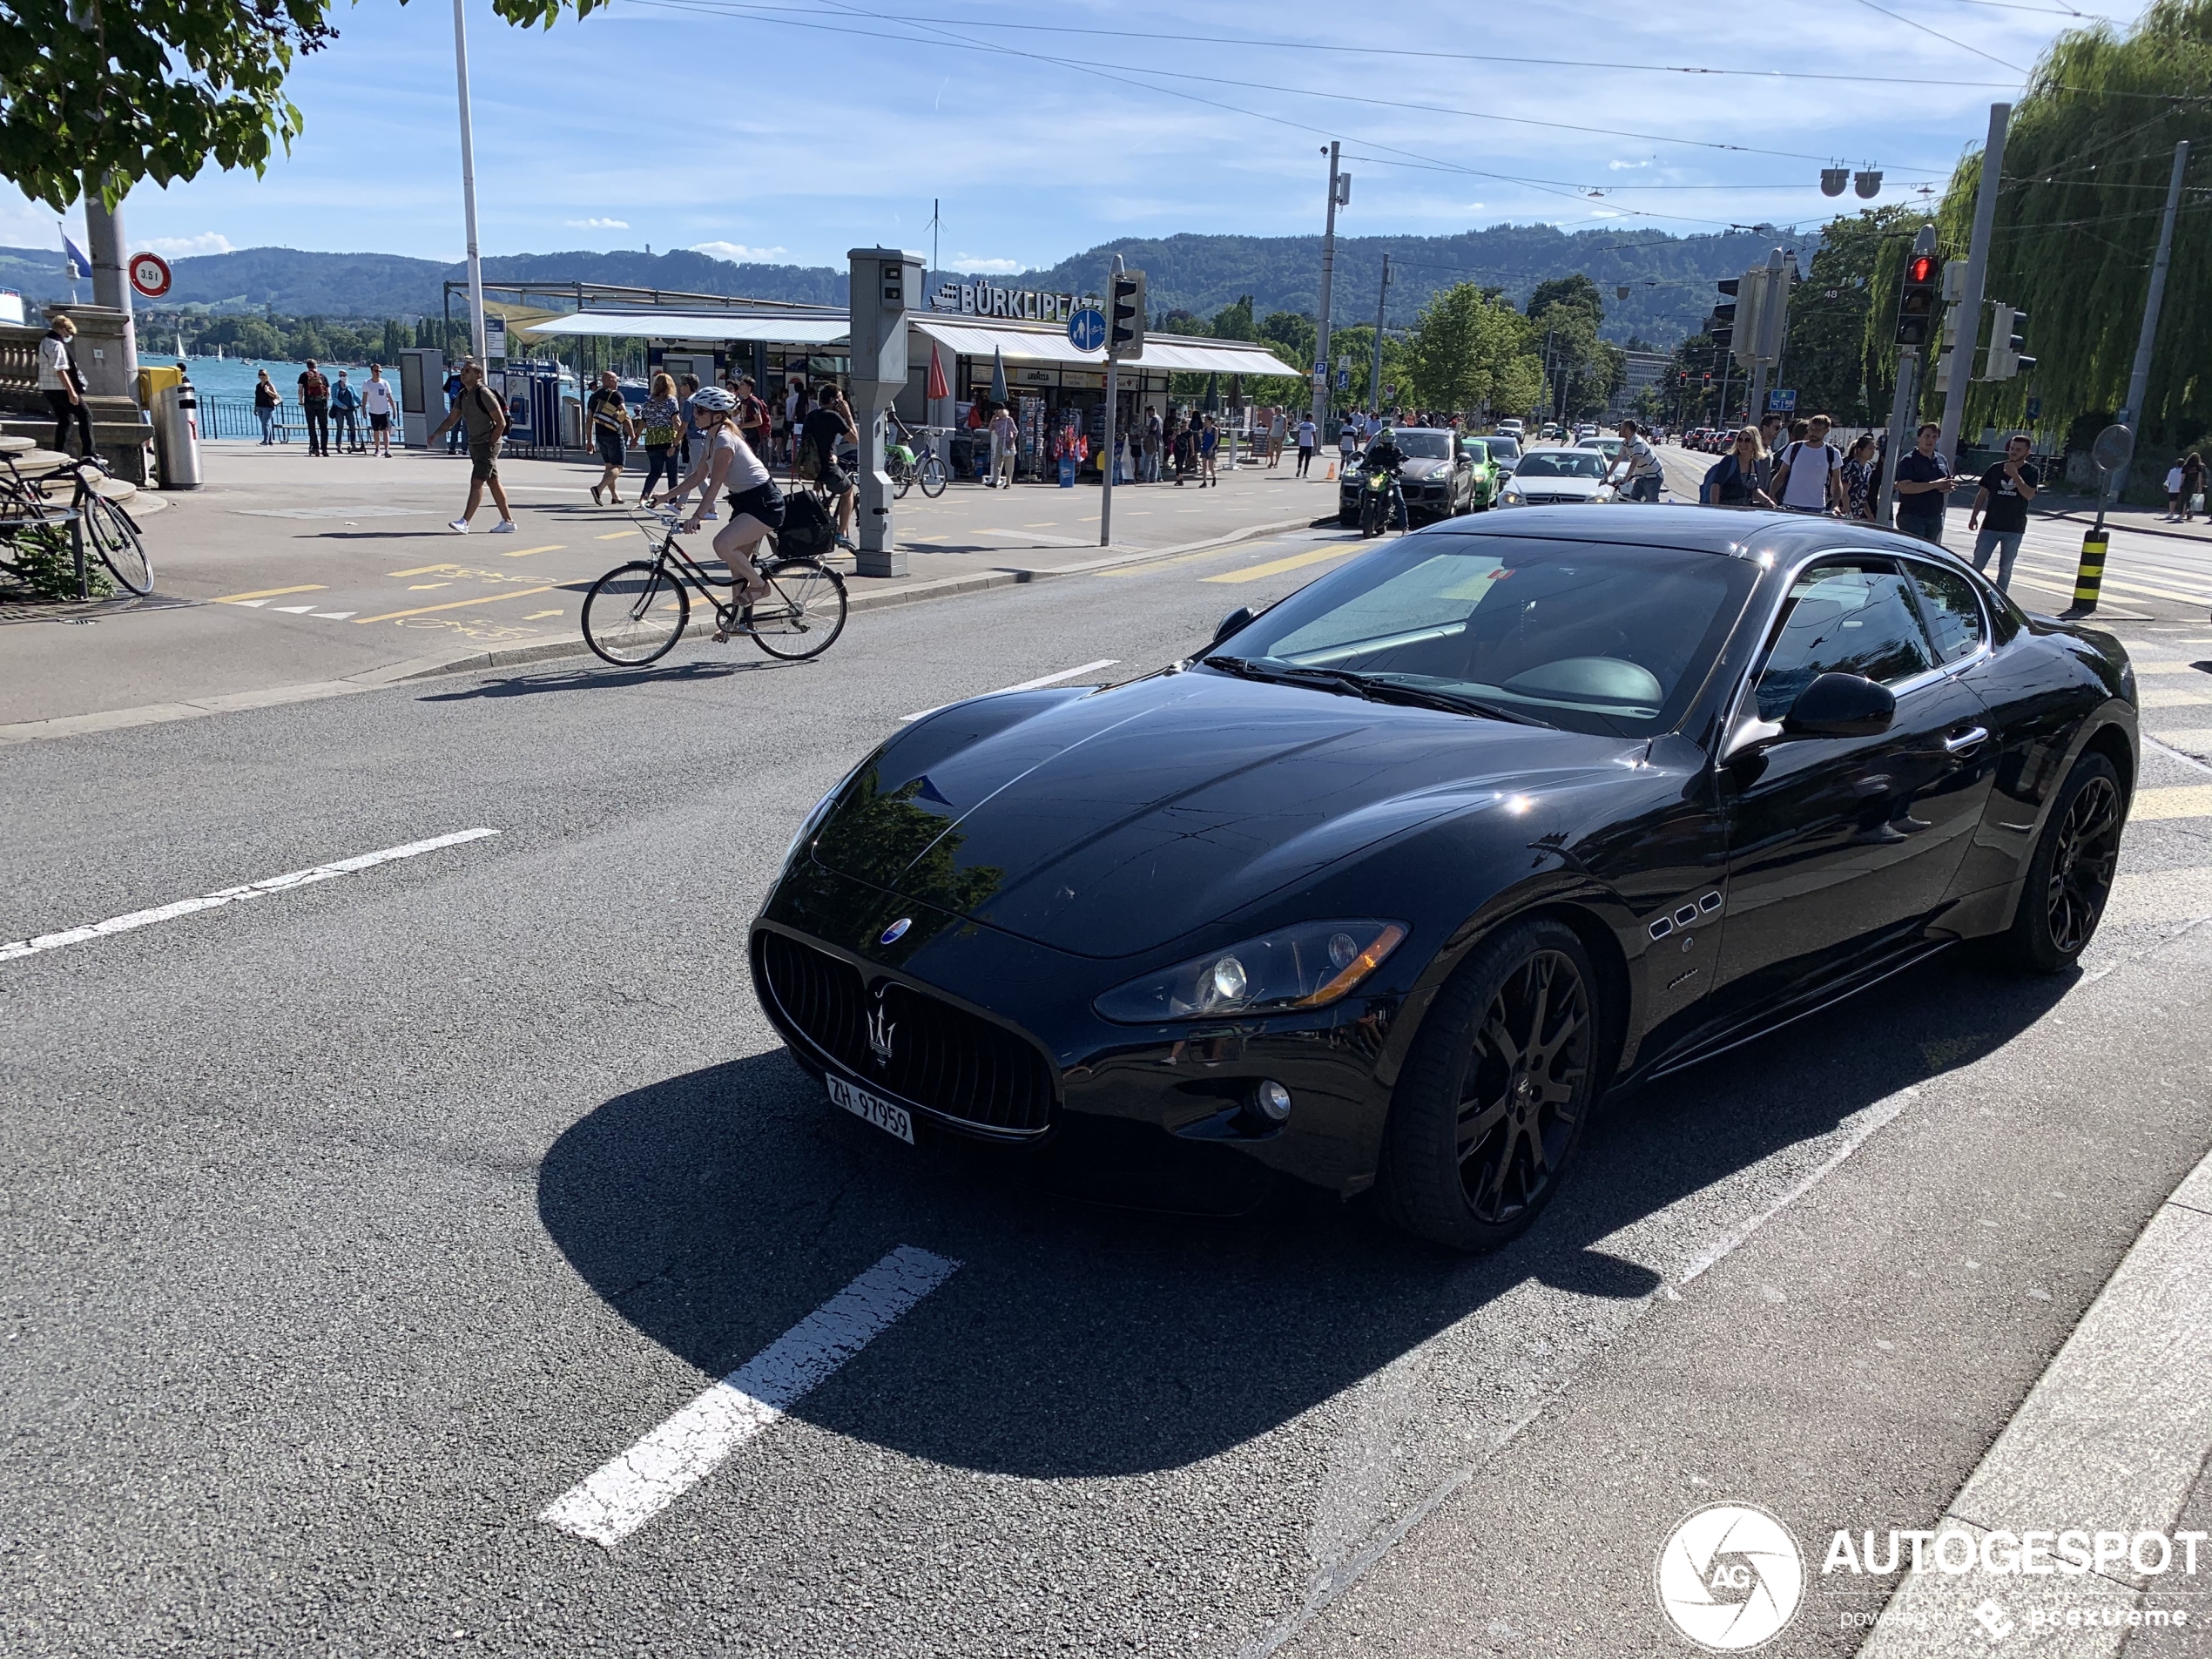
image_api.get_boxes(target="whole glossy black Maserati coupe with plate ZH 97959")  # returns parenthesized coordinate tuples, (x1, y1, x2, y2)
(750, 507, 2137, 1248)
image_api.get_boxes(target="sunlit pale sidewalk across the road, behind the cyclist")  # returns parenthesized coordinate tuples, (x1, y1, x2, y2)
(0, 445, 1336, 741)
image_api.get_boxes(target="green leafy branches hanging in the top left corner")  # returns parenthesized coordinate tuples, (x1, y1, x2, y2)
(0, 0, 606, 212)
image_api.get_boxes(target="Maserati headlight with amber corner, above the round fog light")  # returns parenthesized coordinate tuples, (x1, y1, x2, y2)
(1093, 921, 1406, 1024)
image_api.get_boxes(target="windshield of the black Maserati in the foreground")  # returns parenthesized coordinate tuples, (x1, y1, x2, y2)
(1217, 533, 1758, 737)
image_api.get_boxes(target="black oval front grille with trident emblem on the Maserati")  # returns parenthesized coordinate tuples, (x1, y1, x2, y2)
(754, 929, 1053, 1135)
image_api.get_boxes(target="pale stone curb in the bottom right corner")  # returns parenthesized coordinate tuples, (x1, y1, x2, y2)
(1858, 1157, 2212, 1659)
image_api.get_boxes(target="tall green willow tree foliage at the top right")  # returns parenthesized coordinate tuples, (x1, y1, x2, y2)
(1940, 0, 2212, 449)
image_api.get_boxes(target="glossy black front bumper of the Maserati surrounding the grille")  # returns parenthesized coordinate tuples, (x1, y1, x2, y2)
(748, 853, 1402, 1195)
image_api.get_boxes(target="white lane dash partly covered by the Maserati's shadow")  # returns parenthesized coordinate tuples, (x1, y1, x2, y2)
(537, 1245, 960, 1548)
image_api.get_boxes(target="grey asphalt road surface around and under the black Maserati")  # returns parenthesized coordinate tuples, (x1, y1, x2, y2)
(0, 513, 2212, 1656)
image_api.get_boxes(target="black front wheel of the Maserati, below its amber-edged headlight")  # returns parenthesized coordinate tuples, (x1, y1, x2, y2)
(1376, 918, 1602, 1250)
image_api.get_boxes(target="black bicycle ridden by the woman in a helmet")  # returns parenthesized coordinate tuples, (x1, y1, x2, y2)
(584, 509, 845, 668)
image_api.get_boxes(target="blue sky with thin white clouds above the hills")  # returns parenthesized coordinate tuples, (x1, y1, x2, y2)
(0, 0, 2134, 272)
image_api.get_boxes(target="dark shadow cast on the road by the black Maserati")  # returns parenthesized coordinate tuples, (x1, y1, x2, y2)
(537, 960, 2068, 1478)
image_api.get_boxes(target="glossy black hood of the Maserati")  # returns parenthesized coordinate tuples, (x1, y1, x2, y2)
(812, 672, 1643, 958)
